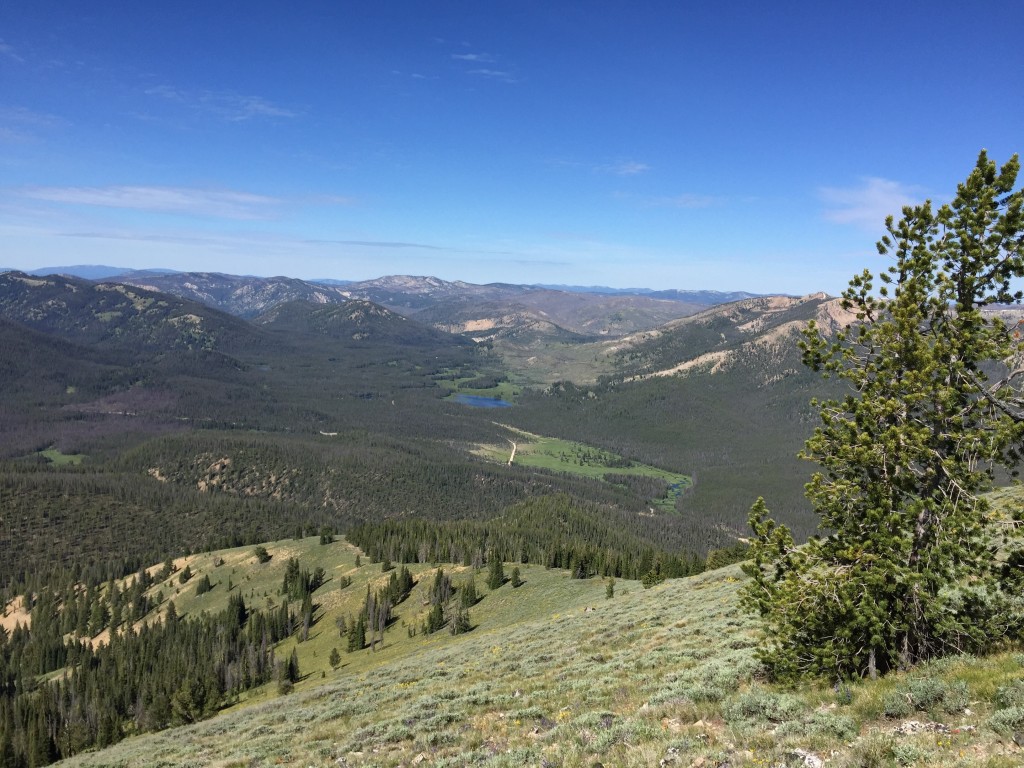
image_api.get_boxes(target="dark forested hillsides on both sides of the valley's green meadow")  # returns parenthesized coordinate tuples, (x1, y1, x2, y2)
(0, 273, 839, 586)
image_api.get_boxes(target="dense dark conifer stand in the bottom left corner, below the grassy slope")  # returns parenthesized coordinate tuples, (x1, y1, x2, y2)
(0, 571, 300, 768)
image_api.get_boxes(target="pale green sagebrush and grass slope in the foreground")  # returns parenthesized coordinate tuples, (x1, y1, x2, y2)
(58, 539, 1024, 768)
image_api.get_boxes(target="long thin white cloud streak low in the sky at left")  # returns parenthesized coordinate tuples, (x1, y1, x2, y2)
(22, 186, 283, 219)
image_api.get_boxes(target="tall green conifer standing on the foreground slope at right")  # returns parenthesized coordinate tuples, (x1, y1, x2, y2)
(744, 152, 1024, 679)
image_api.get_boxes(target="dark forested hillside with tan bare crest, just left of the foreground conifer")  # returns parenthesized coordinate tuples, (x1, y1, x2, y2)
(517, 295, 845, 537)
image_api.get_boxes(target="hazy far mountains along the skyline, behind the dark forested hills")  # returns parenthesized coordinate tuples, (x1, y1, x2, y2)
(2, 265, 782, 359)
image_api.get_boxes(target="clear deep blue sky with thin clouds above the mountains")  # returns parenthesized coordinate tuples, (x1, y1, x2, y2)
(0, 0, 1024, 293)
